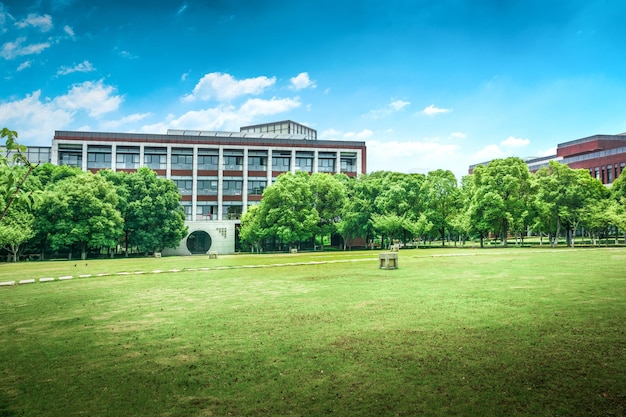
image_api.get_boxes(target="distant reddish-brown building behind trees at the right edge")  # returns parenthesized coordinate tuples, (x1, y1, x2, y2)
(468, 133, 626, 185)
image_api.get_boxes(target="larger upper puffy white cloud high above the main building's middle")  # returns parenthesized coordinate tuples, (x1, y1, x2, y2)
(183, 72, 276, 102)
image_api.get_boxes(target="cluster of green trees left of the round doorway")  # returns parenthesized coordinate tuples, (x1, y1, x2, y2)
(0, 128, 187, 260)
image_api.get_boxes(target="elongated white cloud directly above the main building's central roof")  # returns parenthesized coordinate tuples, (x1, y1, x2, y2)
(141, 98, 301, 133)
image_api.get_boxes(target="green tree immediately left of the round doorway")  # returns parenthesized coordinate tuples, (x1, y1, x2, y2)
(98, 167, 188, 254)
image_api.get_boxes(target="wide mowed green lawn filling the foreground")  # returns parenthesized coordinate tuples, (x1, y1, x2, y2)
(0, 249, 626, 416)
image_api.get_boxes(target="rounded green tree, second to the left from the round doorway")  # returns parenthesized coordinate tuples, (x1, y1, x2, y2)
(40, 172, 123, 259)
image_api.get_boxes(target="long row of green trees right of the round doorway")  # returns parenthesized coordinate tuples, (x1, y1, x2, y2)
(240, 158, 626, 250)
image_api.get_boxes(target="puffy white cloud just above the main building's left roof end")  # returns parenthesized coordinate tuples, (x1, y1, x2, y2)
(54, 80, 124, 117)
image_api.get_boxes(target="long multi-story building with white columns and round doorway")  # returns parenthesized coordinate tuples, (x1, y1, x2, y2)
(50, 121, 366, 254)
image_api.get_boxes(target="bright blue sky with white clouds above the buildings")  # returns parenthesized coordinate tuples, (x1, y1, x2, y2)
(0, 0, 626, 179)
